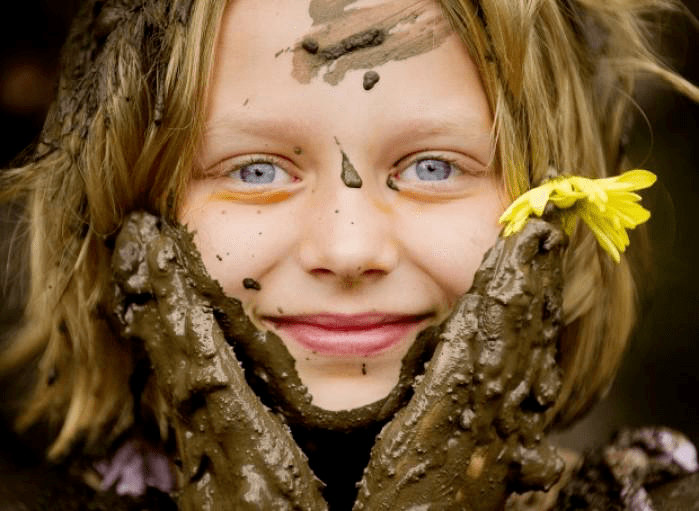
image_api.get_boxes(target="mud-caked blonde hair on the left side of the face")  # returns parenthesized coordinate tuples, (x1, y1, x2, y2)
(0, 0, 225, 458)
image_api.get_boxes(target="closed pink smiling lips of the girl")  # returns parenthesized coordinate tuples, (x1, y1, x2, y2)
(265, 314, 430, 357)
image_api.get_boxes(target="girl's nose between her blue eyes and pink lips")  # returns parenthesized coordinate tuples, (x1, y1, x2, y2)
(300, 183, 399, 283)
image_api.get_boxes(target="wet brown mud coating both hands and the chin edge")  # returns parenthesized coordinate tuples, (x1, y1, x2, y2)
(113, 213, 565, 511)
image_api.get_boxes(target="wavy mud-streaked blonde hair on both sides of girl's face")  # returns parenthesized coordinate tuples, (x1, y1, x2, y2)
(0, 0, 699, 458)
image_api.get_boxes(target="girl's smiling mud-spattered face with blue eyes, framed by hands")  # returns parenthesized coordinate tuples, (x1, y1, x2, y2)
(179, 0, 505, 410)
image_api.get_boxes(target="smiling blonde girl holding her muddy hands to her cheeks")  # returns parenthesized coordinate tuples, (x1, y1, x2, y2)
(2, 0, 699, 509)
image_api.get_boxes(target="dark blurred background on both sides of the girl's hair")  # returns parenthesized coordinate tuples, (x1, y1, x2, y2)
(0, 0, 699, 451)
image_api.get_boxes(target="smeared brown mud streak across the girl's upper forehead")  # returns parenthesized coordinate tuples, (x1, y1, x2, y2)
(291, 0, 451, 85)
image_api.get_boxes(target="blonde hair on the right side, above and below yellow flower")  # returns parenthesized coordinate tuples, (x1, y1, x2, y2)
(441, 0, 699, 424)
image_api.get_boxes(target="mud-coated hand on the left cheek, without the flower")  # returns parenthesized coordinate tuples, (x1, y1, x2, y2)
(113, 213, 327, 511)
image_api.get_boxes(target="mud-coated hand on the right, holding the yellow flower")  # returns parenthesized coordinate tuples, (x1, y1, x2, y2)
(354, 220, 565, 511)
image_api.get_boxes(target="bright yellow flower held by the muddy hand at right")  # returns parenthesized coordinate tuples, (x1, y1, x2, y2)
(500, 170, 656, 263)
